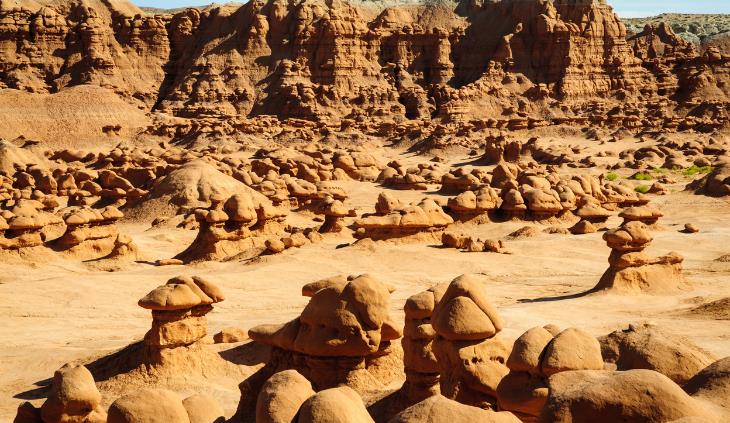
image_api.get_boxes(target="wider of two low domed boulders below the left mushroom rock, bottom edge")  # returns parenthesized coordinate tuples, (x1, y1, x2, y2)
(107, 388, 190, 423)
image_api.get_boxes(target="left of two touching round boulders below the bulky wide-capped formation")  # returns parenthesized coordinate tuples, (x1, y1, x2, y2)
(256, 370, 314, 423)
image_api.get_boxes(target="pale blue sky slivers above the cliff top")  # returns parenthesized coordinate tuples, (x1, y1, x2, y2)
(132, 0, 730, 18)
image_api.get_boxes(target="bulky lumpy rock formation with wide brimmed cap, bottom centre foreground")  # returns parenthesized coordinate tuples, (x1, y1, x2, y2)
(245, 275, 401, 413)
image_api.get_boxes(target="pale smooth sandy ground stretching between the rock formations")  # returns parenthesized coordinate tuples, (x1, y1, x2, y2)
(0, 157, 730, 422)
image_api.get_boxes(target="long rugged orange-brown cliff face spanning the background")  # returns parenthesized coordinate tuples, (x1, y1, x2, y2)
(0, 0, 730, 136)
